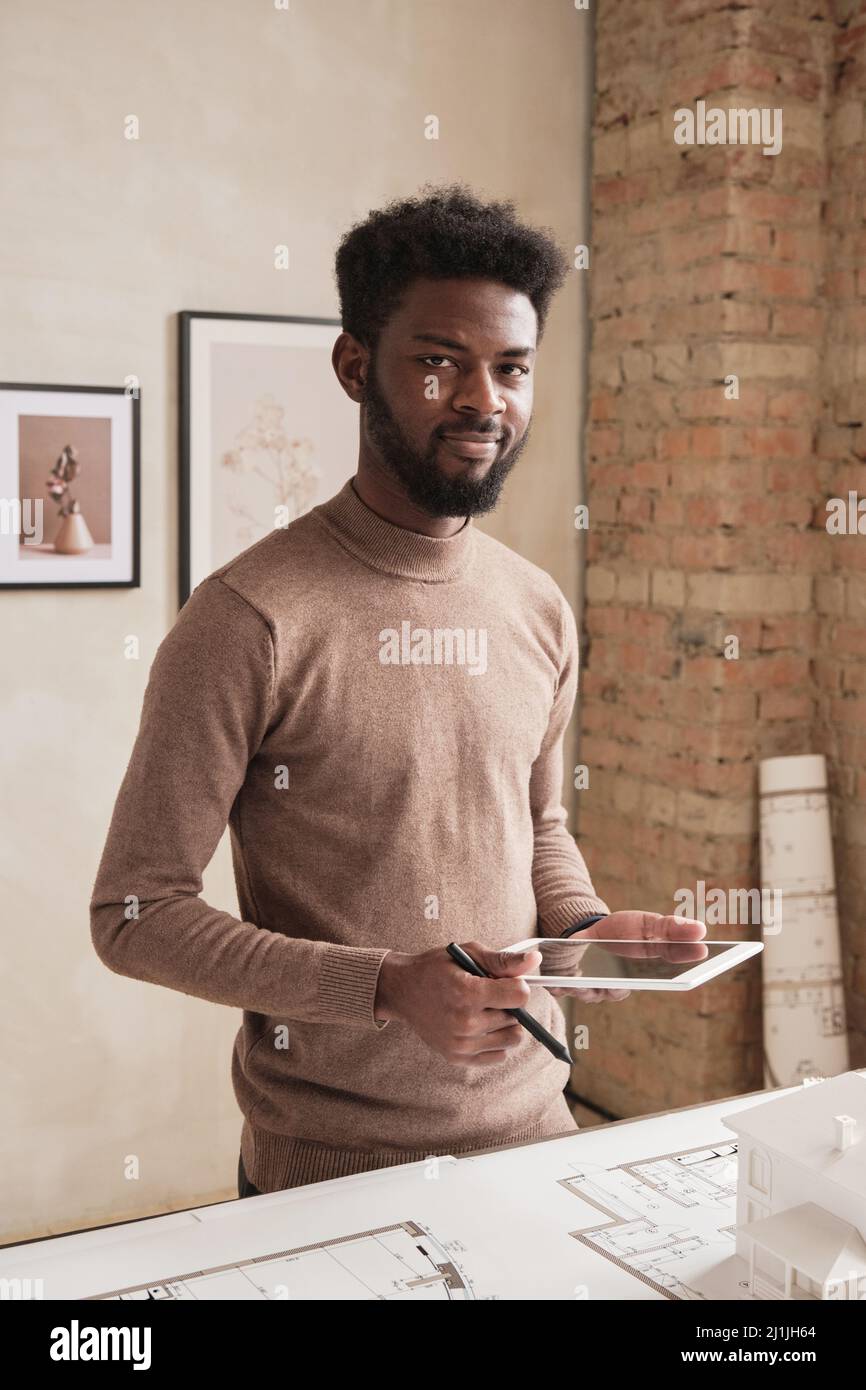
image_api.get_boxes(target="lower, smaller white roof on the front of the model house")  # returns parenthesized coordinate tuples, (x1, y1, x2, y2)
(740, 1202, 866, 1284)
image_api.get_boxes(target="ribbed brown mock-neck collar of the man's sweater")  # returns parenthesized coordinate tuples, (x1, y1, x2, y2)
(313, 478, 475, 584)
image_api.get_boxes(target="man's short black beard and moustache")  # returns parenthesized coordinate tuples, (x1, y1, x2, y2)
(364, 357, 530, 517)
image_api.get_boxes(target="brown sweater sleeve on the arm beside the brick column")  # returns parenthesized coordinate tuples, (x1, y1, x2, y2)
(530, 595, 610, 937)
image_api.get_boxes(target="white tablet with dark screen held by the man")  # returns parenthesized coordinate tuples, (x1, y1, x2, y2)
(506, 935, 763, 991)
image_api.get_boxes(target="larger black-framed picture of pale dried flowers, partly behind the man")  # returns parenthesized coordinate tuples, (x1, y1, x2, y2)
(179, 310, 357, 606)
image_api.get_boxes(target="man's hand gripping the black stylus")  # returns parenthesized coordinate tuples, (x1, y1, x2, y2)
(374, 941, 541, 1066)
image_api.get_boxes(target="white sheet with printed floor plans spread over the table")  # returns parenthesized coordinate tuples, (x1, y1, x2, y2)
(0, 1091, 800, 1301)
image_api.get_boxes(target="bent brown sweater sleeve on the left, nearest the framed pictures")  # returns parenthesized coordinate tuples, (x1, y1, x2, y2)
(90, 575, 388, 1030)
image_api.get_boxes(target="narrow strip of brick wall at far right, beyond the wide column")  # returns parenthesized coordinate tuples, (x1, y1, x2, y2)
(815, 0, 866, 1050)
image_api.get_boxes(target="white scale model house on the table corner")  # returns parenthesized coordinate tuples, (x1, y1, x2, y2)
(723, 1072, 866, 1300)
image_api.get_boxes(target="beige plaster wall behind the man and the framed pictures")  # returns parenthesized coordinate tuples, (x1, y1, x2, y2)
(0, 0, 592, 1241)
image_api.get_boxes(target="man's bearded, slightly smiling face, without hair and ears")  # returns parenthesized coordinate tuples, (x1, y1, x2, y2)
(361, 279, 538, 517)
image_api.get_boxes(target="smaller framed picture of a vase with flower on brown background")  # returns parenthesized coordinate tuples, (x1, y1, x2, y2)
(0, 382, 140, 589)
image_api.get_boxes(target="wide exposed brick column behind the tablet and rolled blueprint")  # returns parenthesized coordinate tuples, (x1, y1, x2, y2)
(573, 0, 866, 1115)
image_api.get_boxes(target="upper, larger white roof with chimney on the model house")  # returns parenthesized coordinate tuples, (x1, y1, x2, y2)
(721, 1072, 866, 1197)
